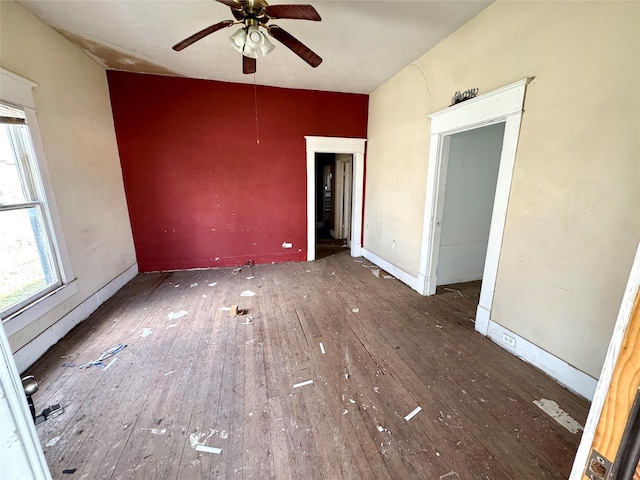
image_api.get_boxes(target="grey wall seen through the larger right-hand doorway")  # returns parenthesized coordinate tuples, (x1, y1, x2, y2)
(434, 122, 505, 286)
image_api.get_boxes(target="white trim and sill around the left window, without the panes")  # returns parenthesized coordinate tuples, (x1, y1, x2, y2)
(0, 67, 78, 337)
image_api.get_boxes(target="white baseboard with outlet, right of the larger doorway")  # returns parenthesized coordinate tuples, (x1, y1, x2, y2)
(488, 318, 598, 400)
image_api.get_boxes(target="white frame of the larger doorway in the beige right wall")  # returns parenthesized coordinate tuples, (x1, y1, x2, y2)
(417, 78, 532, 335)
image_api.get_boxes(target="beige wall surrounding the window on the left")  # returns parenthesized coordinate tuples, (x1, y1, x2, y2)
(0, 0, 136, 351)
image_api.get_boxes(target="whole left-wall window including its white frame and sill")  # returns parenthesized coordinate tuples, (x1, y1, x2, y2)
(0, 67, 78, 337)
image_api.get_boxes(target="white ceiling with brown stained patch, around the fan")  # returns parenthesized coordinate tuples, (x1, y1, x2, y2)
(18, 0, 491, 94)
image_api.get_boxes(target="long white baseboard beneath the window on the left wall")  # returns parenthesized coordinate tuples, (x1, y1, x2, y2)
(13, 263, 138, 373)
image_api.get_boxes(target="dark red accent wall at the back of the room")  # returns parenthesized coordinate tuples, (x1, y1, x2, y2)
(107, 71, 369, 272)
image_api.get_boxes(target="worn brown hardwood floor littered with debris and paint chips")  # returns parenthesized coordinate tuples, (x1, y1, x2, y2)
(26, 251, 589, 480)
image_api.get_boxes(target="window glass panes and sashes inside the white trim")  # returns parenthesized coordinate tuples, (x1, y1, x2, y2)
(0, 103, 61, 318)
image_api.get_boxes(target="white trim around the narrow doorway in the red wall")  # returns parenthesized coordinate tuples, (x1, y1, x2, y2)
(304, 136, 367, 261)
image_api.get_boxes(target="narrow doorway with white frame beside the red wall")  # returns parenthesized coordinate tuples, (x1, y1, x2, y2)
(305, 137, 366, 261)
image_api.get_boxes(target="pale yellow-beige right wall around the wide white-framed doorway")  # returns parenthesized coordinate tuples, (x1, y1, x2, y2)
(364, 2, 640, 378)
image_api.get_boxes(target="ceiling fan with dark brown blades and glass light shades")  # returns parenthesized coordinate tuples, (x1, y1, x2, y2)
(173, 0, 322, 73)
